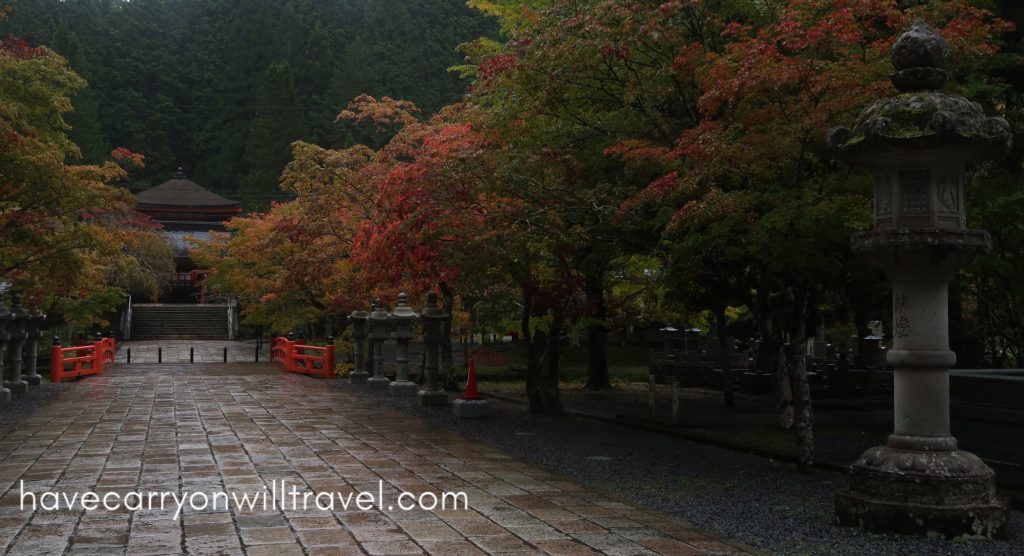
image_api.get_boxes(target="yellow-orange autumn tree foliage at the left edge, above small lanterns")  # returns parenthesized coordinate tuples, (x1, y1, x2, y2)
(0, 30, 171, 325)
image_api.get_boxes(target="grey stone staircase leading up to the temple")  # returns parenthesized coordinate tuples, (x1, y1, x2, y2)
(131, 303, 228, 340)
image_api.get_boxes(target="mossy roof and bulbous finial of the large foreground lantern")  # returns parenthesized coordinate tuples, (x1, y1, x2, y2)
(827, 19, 1012, 162)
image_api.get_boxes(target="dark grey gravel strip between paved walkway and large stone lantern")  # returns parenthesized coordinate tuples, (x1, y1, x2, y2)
(330, 380, 1024, 556)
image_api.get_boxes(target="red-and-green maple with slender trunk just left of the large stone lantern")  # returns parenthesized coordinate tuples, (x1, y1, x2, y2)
(623, 0, 1002, 469)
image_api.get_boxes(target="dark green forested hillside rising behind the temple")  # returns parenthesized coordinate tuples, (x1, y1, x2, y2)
(0, 0, 497, 208)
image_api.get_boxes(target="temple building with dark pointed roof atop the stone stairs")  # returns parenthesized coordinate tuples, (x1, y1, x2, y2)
(135, 168, 242, 302)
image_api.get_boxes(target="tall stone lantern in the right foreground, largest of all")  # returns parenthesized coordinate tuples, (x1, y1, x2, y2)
(828, 20, 1011, 537)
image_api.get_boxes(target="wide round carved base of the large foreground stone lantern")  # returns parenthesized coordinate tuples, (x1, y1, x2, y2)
(836, 446, 1009, 539)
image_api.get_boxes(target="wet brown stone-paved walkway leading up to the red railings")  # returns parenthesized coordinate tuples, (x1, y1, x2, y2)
(0, 365, 742, 556)
